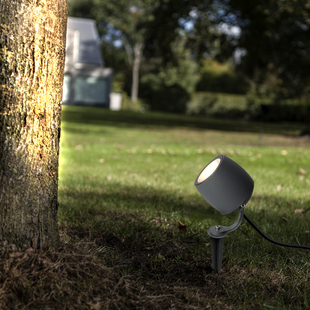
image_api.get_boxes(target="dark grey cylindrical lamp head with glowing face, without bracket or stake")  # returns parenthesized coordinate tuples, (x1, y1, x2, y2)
(195, 155, 254, 215)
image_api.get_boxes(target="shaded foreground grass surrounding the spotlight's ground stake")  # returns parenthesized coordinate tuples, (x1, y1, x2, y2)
(60, 187, 310, 309)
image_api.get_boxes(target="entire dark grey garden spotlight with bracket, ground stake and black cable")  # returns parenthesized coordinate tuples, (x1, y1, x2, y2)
(195, 155, 310, 271)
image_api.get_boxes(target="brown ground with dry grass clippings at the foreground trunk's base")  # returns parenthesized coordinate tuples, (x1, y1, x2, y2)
(0, 223, 294, 310)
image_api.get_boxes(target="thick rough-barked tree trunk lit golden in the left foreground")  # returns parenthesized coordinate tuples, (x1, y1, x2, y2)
(0, 0, 68, 256)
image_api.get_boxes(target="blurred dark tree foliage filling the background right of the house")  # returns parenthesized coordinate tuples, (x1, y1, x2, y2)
(71, 0, 310, 111)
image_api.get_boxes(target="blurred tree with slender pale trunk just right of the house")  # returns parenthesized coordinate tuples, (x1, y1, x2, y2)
(70, 0, 158, 101)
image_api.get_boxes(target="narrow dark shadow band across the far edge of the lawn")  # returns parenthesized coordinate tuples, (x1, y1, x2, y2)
(62, 106, 306, 136)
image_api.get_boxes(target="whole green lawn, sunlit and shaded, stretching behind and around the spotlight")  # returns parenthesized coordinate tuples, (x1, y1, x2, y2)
(59, 106, 310, 309)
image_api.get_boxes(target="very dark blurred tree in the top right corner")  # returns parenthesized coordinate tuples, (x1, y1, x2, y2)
(218, 0, 310, 99)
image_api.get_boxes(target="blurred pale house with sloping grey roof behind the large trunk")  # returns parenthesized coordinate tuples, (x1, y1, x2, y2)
(63, 17, 113, 108)
